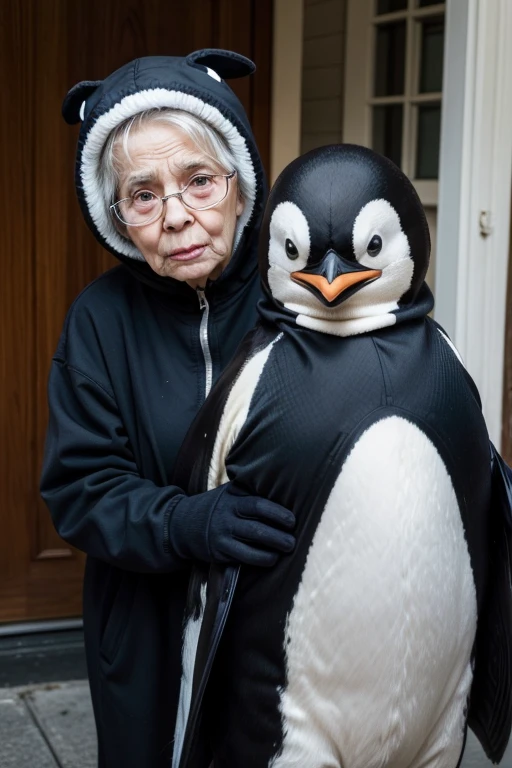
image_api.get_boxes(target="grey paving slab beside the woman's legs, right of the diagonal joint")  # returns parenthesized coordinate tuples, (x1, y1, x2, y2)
(24, 681, 97, 768)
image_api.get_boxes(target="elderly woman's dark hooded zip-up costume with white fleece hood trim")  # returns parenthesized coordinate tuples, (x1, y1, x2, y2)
(41, 50, 274, 768)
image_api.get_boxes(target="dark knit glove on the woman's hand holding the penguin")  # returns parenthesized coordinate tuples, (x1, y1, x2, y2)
(168, 483, 295, 566)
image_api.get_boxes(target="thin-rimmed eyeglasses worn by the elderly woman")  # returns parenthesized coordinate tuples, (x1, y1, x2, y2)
(110, 171, 236, 227)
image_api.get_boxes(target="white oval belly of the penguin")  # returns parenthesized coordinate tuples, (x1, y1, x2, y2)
(270, 416, 477, 768)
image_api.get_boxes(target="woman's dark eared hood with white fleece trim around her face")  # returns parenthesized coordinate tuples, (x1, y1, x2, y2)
(62, 49, 266, 293)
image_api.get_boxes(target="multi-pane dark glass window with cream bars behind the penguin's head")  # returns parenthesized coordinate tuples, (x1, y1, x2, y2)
(360, 0, 444, 190)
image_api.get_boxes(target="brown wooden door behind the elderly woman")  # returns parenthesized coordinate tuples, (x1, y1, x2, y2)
(0, 0, 272, 622)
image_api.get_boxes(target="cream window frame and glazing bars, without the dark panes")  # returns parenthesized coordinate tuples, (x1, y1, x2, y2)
(343, 0, 446, 206)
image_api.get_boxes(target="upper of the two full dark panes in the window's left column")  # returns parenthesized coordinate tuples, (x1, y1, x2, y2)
(374, 21, 405, 96)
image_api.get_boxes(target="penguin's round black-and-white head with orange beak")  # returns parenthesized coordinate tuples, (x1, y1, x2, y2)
(260, 144, 430, 335)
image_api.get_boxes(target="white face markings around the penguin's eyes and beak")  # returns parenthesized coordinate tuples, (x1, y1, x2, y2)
(268, 199, 414, 336)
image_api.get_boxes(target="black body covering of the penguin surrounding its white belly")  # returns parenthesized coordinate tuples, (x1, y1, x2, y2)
(178, 318, 491, 768)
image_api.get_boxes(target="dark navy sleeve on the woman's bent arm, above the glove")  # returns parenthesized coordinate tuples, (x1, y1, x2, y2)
(41, 360, 186, 572)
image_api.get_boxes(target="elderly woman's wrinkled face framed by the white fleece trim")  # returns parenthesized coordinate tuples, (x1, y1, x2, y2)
(115, 122, 244, 288)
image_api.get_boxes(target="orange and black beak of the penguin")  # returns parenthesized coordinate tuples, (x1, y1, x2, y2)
(290, 249, 382, 307)
